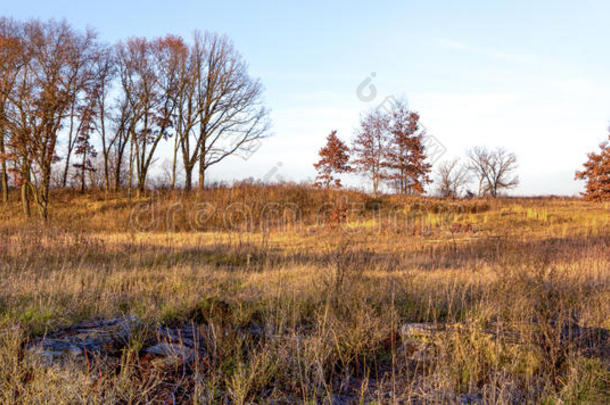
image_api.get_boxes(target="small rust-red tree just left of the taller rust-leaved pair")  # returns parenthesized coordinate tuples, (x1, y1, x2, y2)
(313, 131, 352, 188)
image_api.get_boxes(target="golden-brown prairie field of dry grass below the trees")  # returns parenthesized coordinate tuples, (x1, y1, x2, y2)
(0, 184, 610, 404)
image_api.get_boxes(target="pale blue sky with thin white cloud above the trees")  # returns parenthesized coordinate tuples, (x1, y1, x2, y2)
(0, 0, 610, 195)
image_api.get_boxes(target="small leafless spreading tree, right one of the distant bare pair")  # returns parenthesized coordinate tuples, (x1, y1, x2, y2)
(468, 147, 519, 197)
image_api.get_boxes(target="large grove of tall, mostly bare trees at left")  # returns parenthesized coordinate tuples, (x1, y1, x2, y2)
(0, 18, 270, 219)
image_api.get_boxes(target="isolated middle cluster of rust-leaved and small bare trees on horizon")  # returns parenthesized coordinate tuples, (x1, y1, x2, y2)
(314, 100, 519, 198)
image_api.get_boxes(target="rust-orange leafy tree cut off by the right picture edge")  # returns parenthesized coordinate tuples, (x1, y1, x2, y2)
(576, 136, 610, 201)
